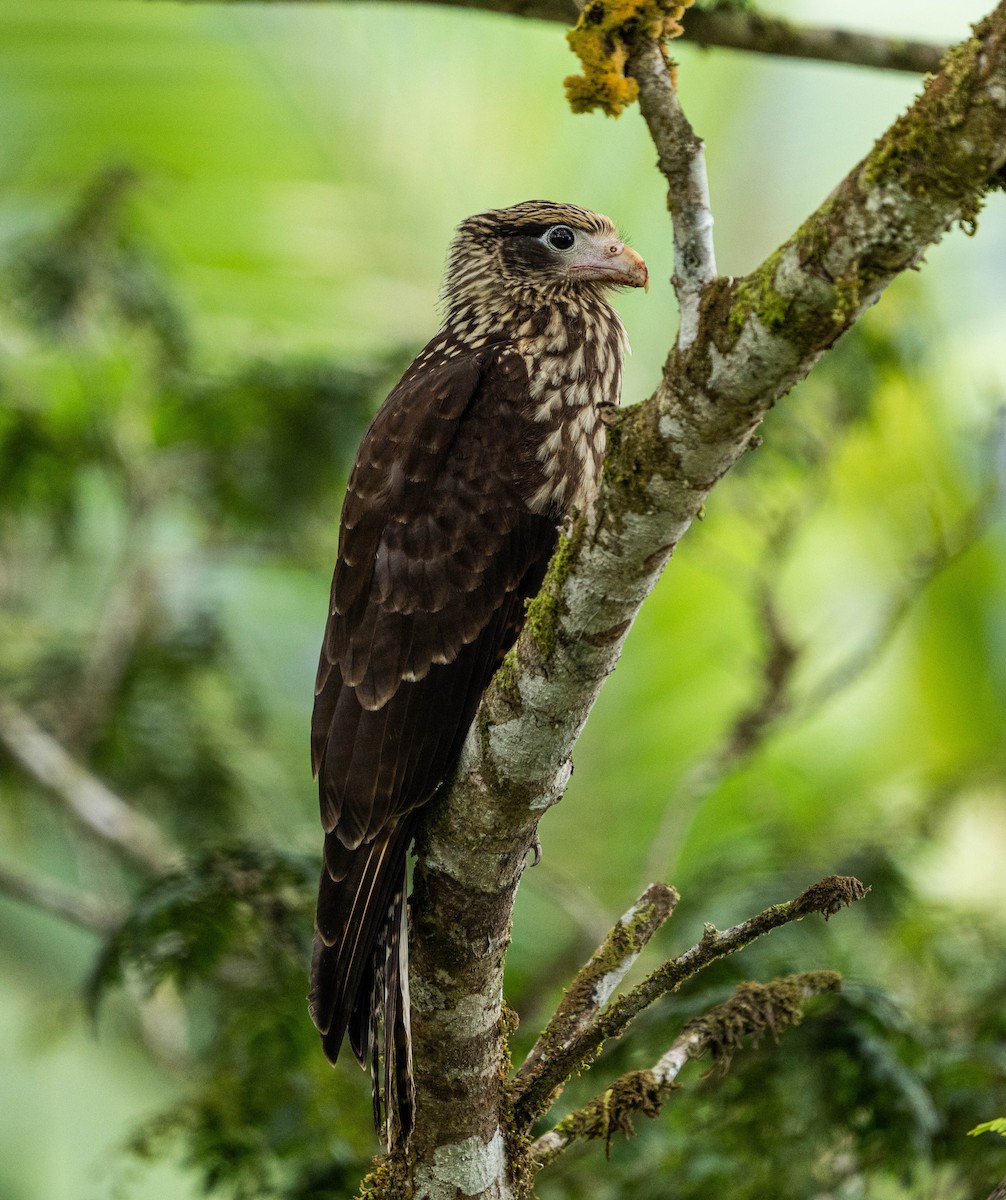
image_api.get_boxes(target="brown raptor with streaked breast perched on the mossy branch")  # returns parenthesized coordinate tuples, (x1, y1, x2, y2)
(309, 200, 648, 1147)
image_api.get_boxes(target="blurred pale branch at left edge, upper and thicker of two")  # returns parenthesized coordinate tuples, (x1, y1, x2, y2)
(0, 696, 180, 874)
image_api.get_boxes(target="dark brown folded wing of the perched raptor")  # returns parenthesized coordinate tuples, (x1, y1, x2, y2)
(311, 338, 556, 1104)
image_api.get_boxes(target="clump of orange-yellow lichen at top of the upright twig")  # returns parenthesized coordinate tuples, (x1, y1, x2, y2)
(563, 0, 693, 116)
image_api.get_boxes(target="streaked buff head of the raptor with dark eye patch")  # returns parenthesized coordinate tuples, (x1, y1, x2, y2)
(443, 200, 649, 324)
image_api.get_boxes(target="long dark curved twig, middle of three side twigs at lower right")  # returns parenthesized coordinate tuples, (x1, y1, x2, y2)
(514, 875, 869, 1128)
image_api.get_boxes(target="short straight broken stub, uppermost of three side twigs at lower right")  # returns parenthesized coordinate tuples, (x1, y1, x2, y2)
(515, 883, 678, 1090)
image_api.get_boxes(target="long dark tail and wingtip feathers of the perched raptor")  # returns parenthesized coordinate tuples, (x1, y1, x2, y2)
(309, 817, 415, 1145)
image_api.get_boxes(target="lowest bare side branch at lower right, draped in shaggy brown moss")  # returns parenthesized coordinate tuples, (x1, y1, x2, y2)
(531, 971, 842, 1166)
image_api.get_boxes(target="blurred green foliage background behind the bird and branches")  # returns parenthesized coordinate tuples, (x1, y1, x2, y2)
(0, 0, 1006, 1200)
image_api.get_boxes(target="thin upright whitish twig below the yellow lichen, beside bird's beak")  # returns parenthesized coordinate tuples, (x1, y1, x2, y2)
(628, 40, 717, 350)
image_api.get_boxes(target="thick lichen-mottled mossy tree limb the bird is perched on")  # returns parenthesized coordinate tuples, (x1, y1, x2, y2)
(412, 9, 1006, 1196)
